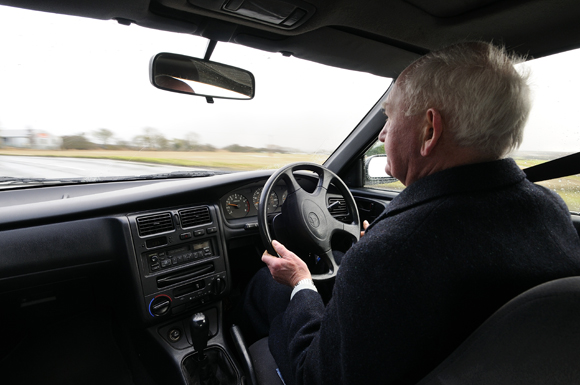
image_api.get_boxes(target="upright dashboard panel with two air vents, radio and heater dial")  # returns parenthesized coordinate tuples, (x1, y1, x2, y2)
(129, 205, 228, 321)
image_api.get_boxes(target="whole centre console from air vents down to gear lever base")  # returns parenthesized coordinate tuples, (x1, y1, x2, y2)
(128, 204, 245, 385)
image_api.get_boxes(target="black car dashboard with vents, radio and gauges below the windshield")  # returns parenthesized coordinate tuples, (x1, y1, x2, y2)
(0, 170, 384, 383)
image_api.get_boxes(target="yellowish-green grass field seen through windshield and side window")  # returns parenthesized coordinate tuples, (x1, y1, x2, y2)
(0, 149, 580, 212)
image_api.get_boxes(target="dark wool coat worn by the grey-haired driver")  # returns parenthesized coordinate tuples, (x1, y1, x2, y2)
(269, 159, 580, 385)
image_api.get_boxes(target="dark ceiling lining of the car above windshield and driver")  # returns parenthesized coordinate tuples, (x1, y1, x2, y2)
(0, 0, 580, 77)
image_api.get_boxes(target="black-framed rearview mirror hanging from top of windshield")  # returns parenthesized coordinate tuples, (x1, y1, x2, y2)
(149, 52, 255, 100)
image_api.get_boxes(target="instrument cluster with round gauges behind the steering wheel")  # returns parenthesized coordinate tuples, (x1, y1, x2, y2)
(220, 182, 288, 219)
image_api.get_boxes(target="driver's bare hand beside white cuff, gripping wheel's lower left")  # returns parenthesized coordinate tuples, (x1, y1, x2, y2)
(262, 241, 312, 287)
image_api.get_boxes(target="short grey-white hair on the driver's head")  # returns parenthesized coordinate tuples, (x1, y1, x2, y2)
(397, 42, 531, 159)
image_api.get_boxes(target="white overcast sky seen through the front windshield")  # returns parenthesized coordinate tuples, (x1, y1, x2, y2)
(0, 7, 390, 152)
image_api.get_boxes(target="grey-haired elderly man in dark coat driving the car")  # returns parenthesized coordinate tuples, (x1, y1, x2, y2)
(241, 43, 580, 385)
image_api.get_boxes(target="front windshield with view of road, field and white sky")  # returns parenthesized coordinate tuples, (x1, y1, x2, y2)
(0, 7, 391, 187)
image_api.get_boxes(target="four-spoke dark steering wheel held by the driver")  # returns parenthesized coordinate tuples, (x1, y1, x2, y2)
(258, 162, 360, 281)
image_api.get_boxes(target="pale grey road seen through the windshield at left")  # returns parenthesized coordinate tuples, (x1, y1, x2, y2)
(0, 156, 205, 178)
